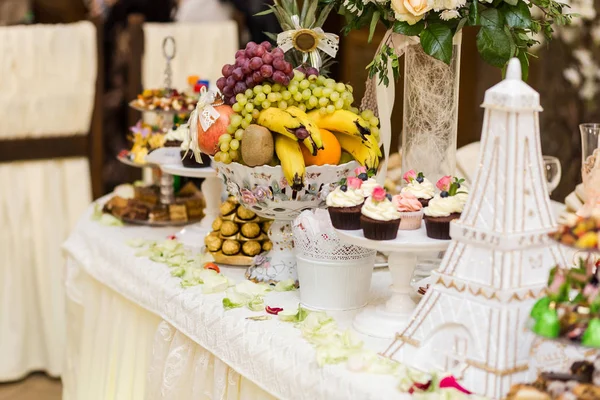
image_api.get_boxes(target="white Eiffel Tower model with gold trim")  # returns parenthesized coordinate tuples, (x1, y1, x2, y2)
(384, 59, 563, 399)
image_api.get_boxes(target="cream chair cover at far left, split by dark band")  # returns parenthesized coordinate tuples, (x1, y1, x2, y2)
(0, 22, 97, 381)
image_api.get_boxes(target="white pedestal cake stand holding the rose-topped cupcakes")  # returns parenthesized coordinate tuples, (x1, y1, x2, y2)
(336, 224, 450, 338)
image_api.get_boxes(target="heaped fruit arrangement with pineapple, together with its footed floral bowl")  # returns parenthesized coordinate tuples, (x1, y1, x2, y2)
(189, 1, 382, 283)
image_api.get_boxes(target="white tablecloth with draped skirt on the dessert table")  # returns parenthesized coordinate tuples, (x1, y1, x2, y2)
(63, 205, 409, 400)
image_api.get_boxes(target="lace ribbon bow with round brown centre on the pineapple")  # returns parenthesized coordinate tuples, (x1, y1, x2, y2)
(277, 15, 340, 69)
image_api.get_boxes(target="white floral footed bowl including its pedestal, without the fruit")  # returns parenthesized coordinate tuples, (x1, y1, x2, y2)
(214, 161, 359, 283)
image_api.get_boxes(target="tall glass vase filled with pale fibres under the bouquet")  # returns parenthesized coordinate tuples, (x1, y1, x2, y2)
(402, 32, 462, 183)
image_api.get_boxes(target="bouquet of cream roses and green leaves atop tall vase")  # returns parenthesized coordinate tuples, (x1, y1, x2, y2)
(336, 0, 573, 86)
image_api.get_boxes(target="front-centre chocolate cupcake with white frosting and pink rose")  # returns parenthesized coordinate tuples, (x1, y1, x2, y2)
(360, 186, 400, 240)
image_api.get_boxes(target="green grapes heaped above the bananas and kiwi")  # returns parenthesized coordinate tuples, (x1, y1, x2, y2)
(215, 70, 360, 163)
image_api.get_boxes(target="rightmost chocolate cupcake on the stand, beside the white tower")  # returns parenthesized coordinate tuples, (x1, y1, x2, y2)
(423, 176, 466, 240)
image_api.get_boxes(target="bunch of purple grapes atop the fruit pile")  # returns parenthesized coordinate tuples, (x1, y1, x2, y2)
(217, 41, 294, 105)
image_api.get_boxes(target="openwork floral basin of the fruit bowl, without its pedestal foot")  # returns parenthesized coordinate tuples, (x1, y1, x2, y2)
(214, 161, 358, 221)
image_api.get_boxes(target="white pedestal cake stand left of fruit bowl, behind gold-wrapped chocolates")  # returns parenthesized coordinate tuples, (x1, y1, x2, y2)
(159, 163, 223, 247)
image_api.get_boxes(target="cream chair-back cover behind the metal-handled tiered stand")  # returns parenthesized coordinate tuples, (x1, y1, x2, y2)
(142, 21, 238, 90)
